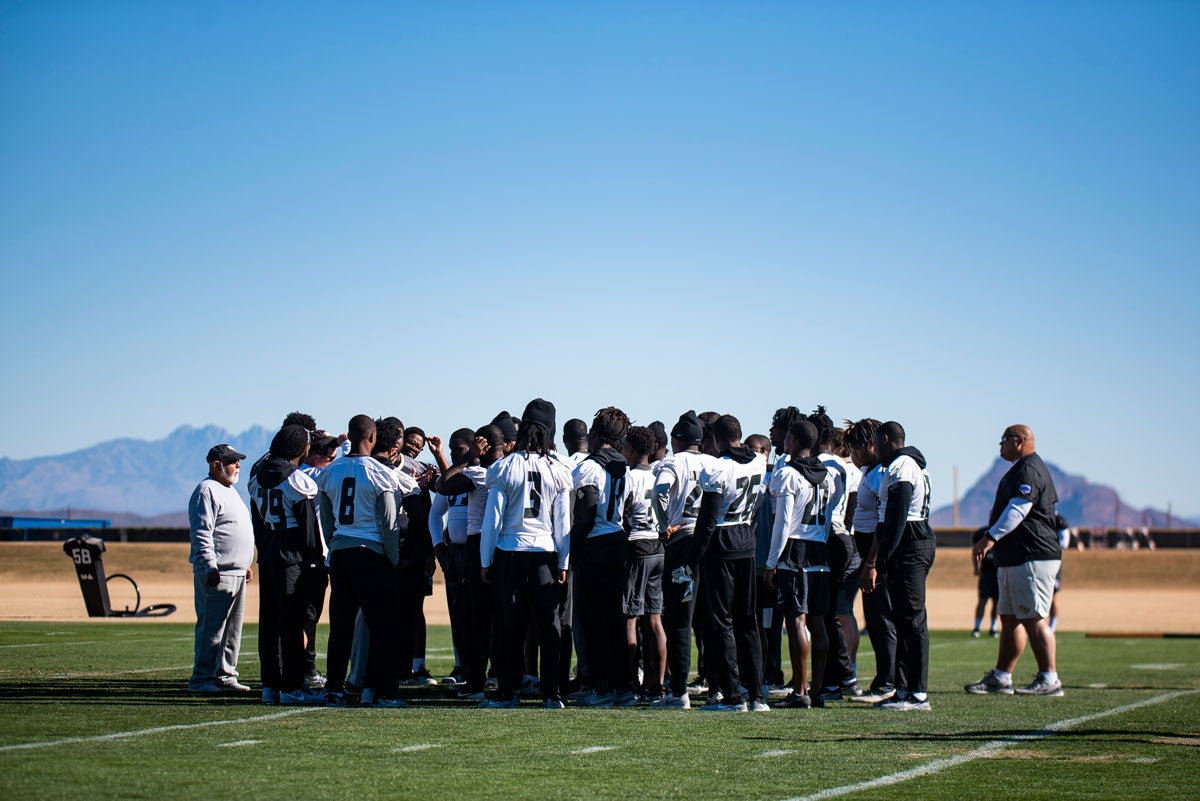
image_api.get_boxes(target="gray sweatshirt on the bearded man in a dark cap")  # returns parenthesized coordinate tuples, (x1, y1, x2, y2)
(187, 477, 254, 576)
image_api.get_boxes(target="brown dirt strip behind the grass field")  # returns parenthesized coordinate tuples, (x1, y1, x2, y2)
(0, 542, 1200, 633)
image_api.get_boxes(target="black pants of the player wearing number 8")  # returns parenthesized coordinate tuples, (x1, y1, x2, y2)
(325, 547, 404, 698)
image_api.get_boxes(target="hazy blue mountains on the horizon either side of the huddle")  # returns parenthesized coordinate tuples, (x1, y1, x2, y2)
(0, 426, 1196, 528)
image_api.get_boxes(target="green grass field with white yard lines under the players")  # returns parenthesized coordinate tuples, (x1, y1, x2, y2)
(0, 622, 1200, 801)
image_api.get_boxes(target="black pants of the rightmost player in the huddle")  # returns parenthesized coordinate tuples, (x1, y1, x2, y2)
(887, 540, 937, 693)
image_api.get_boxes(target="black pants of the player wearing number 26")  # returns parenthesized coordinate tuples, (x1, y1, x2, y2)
(700, 553, 762, 704)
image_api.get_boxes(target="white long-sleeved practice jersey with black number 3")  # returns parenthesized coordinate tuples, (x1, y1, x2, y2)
(480, 451, 571, 568)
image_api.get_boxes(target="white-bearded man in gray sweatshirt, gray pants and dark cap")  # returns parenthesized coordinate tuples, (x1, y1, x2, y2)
(187, 444, 254, 694)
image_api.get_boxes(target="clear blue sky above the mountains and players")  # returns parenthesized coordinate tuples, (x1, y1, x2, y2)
(0, 0, 1200, 516)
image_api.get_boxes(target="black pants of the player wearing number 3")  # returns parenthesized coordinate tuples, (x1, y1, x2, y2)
(490, 550, 560, 699)
